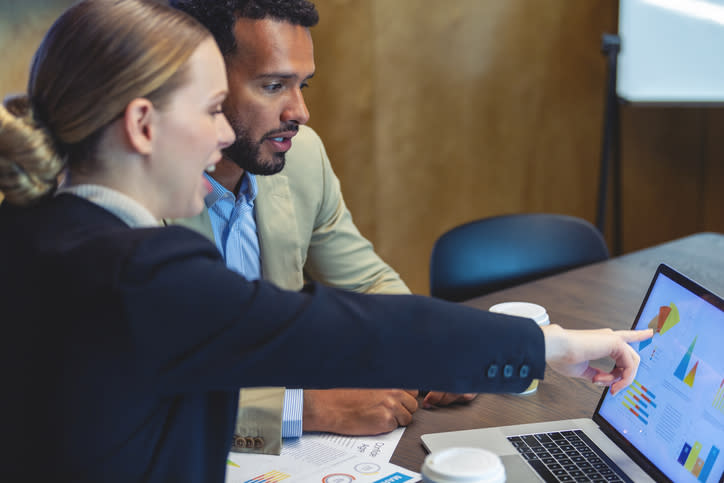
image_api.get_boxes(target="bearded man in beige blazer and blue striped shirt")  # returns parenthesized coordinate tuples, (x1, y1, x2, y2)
(171, 0, 474, 453)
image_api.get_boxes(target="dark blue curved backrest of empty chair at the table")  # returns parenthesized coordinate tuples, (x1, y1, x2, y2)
(430, 213, 609, 301)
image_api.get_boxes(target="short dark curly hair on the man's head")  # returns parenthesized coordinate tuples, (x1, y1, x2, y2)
(169, 0, 319, 57)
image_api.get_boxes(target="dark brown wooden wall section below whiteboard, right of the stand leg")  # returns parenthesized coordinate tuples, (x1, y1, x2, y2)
(621, 106, 706, 252)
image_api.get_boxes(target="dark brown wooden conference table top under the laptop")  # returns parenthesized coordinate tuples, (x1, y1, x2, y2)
(390, 233, 724, 471)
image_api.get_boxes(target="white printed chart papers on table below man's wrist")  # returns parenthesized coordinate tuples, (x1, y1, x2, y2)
(226, 428, 419, 483)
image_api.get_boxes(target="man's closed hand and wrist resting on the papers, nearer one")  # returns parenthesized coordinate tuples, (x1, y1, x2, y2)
(303, 389, 417, 436)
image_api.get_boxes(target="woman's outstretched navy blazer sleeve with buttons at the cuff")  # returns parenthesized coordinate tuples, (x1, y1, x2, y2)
(119, 227, 545, 396)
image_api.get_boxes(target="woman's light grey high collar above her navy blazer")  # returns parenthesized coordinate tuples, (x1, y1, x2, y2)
(55, 184, 160, 228)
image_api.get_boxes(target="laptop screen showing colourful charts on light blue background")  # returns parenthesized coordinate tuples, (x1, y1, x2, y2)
(593, 265, 724, 482)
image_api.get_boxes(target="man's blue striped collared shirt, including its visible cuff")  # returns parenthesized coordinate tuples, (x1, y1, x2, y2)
(204, 173, 304, 438)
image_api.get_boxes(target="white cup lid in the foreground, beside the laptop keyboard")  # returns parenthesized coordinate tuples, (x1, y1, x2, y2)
(421, 448, 505, 483)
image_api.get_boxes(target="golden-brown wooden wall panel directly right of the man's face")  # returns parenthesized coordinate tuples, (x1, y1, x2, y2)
(305, 0, 377, 240)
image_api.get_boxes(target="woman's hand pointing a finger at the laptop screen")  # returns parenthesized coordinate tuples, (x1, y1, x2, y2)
(543, 324, 654, 394)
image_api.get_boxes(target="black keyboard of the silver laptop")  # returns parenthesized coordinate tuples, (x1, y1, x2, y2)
(508, 430, 633, 483)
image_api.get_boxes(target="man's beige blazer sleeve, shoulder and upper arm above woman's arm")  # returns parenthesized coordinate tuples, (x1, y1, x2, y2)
(290, 127, 410, 294)
